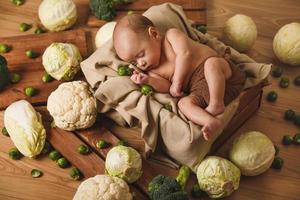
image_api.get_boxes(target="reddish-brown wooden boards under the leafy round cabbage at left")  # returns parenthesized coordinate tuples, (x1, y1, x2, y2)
(0, 29, 88, 110)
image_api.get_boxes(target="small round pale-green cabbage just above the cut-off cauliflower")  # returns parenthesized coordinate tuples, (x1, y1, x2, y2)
(105, 145, 142, 183)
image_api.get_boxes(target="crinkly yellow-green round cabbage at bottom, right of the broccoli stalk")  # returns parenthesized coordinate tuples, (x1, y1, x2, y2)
(197, 156, 241, 198)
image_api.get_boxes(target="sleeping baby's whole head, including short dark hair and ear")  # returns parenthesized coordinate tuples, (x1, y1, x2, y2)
(113, 14, 161, 71)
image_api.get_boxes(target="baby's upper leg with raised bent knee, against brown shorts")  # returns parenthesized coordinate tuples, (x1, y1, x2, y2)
(204, 57, 232, 116)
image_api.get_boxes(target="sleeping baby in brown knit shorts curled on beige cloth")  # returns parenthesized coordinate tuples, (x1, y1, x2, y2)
(113, 14, 245, 140)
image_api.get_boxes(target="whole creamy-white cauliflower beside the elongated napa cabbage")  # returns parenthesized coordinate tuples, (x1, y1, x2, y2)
(47, 81, 97, 131)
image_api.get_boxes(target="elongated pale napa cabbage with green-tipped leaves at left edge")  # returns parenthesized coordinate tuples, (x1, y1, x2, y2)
(4, 100, 46, 158)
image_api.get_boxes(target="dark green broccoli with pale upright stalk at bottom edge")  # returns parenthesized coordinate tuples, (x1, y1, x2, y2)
(148, 166, 190, 200)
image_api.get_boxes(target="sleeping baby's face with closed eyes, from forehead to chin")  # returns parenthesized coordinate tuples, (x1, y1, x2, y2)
(114, 27, 161, 71)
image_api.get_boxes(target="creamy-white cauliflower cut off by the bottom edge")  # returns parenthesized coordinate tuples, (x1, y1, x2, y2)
(73, 175, 132, 200)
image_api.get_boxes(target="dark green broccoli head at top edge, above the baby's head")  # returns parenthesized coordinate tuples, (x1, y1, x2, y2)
(90, 0, 133, 21)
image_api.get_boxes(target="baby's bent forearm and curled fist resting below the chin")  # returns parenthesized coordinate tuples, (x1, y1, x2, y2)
(130, 71, 171, 93)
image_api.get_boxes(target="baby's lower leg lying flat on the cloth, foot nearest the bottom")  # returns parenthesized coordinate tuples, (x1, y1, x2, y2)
(178, 95, 221, 140)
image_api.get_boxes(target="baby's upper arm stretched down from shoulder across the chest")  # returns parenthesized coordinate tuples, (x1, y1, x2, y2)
(166, 28, 191, 96)
